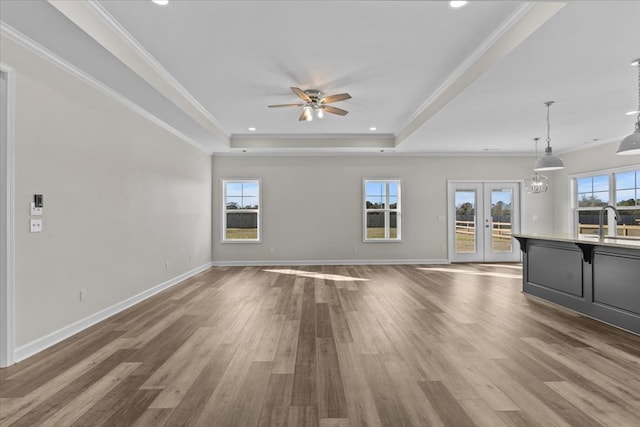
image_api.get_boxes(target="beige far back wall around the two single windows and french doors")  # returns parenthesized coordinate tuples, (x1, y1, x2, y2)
(213, 154, 553, 264)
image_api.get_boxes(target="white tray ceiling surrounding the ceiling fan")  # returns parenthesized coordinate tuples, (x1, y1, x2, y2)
(0, 0, 640, 154)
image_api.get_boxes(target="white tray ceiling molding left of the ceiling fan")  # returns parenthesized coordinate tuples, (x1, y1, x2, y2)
(47, 0, 229, 146)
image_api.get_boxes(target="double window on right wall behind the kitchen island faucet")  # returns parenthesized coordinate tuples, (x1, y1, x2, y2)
(574, 169, 640, 238)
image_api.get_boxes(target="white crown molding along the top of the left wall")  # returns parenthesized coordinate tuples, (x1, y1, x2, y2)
(0, 21, 211, 154)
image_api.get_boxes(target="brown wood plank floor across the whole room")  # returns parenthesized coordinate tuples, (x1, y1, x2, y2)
(0, 264, 640, 427)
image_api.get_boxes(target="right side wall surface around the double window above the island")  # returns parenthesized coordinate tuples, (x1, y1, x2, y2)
(551, 140, 640, 234)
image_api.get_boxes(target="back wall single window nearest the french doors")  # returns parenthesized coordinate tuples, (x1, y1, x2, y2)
(364, 179, 401, 242)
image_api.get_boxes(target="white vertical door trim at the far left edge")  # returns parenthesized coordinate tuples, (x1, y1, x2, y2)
(0, 63, 15, 367)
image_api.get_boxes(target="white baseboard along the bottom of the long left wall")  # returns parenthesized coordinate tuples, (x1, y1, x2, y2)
(14, 262, 213, 363)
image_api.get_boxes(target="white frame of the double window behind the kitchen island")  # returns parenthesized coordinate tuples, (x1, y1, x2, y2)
(569, 164, 640, 236)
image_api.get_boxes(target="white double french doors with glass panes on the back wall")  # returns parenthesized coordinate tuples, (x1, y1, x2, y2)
(448, 181, 520, 262)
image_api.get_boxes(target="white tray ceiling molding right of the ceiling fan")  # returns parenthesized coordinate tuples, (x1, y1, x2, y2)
(396, 2, 566, 146)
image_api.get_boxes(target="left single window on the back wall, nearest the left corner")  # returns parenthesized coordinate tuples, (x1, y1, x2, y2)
(222, 179, 260, 242)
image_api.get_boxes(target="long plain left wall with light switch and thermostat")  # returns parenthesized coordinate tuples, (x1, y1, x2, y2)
(0, 38, 212, 347)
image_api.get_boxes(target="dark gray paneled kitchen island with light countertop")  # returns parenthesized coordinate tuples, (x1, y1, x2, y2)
(514, 234, 640, 335)
